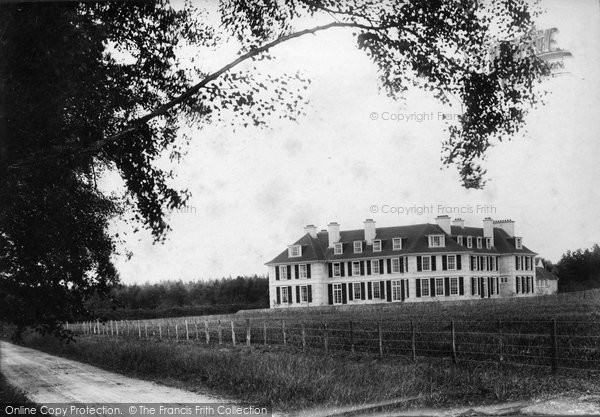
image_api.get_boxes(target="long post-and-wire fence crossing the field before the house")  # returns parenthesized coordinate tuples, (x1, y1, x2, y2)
(67, 316, 600, 371)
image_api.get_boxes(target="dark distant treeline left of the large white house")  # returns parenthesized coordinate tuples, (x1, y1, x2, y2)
(88, 275, 269, 320)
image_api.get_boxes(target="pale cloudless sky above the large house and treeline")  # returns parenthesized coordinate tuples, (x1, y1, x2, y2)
(105, 0, 600, 284)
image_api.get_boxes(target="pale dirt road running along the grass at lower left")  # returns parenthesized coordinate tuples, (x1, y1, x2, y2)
(0, 342, 233, 404)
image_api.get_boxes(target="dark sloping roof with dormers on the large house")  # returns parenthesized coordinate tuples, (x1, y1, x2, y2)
(267, 223, 535, 265)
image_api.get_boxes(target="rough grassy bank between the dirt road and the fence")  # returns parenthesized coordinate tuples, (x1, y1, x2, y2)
(19, 336, 600, 410)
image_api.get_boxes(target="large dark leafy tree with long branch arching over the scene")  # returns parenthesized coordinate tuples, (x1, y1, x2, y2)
(0, 0, 547, 336)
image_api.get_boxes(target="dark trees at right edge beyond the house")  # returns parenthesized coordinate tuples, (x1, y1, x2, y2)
(555, 244, 600, 292)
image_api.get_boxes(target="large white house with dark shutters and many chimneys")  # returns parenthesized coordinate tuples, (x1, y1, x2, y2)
(267, 216, 536, 308)
